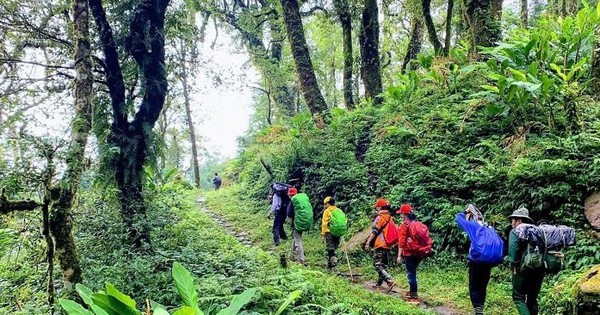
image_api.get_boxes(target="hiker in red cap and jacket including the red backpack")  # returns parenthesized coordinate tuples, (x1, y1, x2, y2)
(396, 204, 433, 303)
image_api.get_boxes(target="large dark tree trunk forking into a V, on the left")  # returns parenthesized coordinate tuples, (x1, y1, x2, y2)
(89, 0, 169, 248)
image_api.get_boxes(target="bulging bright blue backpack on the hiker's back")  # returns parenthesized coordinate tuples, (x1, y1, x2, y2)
(469, 225, 504, 265)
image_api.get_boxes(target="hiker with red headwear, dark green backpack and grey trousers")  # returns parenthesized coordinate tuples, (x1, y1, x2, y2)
(287, 187, 314, 265)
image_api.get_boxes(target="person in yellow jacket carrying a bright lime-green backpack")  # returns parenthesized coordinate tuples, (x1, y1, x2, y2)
(321, 197, 347, 269)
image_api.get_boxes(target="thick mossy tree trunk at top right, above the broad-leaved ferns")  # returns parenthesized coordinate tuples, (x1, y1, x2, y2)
(464, 0, 503, 55)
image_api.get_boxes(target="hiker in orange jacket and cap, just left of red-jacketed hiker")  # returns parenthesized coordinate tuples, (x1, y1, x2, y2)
(365, 198, 398, 292)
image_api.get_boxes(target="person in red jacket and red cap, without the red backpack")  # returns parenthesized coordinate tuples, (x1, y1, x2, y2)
(396, 204, 422, 303)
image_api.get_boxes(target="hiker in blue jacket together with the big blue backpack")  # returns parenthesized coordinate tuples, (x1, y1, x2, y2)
(455, 204, 504, 315)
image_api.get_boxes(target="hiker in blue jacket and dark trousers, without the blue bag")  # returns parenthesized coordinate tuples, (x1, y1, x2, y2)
(455, 205, 495, 315)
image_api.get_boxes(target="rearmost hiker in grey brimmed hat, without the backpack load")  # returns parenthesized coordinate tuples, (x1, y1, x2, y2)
(508, 207, 544, 315)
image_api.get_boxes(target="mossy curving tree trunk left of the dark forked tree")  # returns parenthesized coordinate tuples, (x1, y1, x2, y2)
(50, 0, 94, 286)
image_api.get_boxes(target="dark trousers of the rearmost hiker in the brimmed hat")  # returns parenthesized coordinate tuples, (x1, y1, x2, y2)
(513, 269, 544, 315)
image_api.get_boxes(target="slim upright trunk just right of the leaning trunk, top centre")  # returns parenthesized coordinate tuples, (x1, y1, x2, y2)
(333, 0, 354, 109)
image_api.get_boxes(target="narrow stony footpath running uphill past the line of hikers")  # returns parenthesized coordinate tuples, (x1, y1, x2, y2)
(197, 197, 465, 315)
